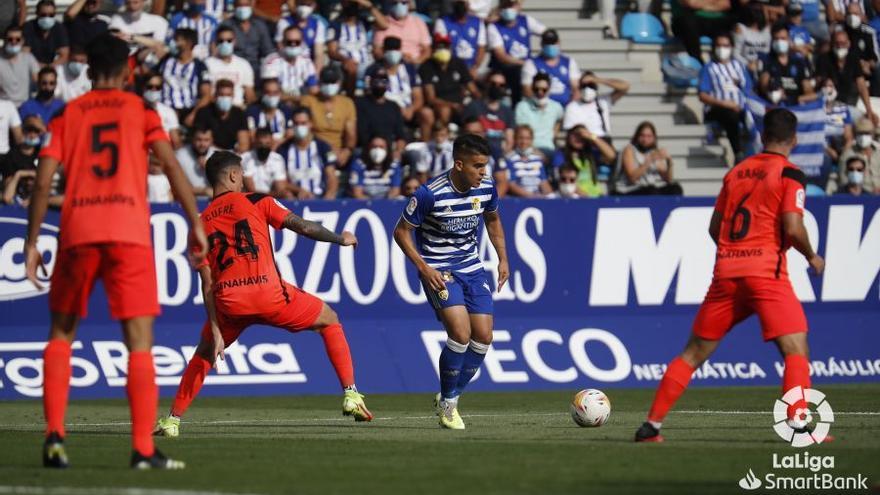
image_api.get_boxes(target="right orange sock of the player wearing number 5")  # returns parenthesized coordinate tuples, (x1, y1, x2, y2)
(125, 351, 159, 457)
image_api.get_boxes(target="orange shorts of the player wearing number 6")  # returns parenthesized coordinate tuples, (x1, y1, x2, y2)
(693, 277, 807, 341)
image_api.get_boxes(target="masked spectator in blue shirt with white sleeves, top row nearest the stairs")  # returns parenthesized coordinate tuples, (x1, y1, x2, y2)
(486, 0, 547, 105)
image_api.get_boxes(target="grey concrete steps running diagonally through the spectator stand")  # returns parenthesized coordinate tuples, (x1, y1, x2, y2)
(523, 0, 727, 196)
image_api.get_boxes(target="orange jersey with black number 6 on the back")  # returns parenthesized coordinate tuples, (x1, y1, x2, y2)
(715, 153, 806, 279)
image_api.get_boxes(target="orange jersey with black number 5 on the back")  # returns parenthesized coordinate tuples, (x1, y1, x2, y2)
(40, 89, 168, 248)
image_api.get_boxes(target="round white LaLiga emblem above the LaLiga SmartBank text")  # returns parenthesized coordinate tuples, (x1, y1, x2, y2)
(773, 387, 834, 447)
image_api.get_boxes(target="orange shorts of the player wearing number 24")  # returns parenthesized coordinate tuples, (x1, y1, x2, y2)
(202, 282, 324, 347)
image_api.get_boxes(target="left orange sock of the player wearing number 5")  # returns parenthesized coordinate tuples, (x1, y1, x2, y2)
(43, 339, 72, 437)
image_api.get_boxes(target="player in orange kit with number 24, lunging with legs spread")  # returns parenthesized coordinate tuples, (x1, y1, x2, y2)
(154, 151, 373, 437)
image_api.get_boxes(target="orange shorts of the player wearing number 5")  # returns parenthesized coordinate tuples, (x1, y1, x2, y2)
(49, 243, 160, 320)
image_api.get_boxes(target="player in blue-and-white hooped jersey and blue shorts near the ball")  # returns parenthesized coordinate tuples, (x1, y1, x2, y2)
(394, 134, 509, 430)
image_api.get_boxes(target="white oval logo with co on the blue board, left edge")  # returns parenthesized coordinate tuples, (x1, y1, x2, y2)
(0, 217, 58, 301)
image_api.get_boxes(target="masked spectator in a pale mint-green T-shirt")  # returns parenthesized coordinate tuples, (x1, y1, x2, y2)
(514, 72, 565, 157)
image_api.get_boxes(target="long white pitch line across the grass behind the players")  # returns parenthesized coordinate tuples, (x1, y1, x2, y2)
(0, 409, 880, 430)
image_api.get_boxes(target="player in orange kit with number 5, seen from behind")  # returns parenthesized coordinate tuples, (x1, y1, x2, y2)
(24, 34, 207, 469)
